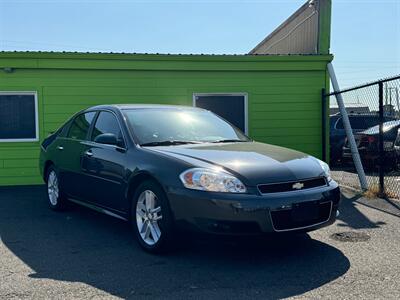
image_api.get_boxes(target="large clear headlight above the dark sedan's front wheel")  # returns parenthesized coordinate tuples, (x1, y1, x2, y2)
(179, 168, 246, 193)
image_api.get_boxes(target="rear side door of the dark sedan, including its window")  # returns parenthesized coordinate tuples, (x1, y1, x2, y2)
(55, 111, 96, 199)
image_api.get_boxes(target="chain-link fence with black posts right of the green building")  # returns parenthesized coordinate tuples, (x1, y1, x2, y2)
(323, 76, 400, 198)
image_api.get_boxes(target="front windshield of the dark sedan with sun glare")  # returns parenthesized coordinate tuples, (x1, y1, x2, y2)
(124, 108, 249, 146)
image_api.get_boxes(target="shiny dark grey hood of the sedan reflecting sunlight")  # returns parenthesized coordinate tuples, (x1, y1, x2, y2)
(147, 142, 323, 185)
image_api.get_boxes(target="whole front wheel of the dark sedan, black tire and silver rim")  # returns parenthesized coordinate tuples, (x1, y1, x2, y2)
(130, 180, 174, 254)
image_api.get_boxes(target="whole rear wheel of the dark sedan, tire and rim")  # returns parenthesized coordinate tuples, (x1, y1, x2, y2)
(46, 166, 67, 211)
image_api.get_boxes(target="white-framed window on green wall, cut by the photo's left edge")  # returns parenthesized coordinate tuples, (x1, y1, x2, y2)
(0, 92, 39, 142)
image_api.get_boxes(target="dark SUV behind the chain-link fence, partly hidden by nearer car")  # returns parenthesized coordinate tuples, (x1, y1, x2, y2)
(329, 113, 395, 165)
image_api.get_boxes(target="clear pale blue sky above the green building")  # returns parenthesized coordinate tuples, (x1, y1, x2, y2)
(0, 0, 400, 88)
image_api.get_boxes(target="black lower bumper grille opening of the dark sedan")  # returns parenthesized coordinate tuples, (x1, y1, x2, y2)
(271, 201, 332, 231)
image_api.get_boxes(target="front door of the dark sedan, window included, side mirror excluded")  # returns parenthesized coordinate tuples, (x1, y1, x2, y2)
(81, 111, 128, 212)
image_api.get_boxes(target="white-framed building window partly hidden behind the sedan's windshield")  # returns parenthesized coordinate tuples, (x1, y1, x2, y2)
(193, 93, 248, 134)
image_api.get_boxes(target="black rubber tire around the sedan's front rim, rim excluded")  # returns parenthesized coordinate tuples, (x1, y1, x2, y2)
(130, 180, 173, 253)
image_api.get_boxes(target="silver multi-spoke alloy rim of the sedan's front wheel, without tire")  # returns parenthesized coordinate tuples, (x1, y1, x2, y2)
(136, 190, 162, 246)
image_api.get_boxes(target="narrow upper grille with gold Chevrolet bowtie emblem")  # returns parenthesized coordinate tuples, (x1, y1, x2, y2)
(258, 177, 327, 194)
